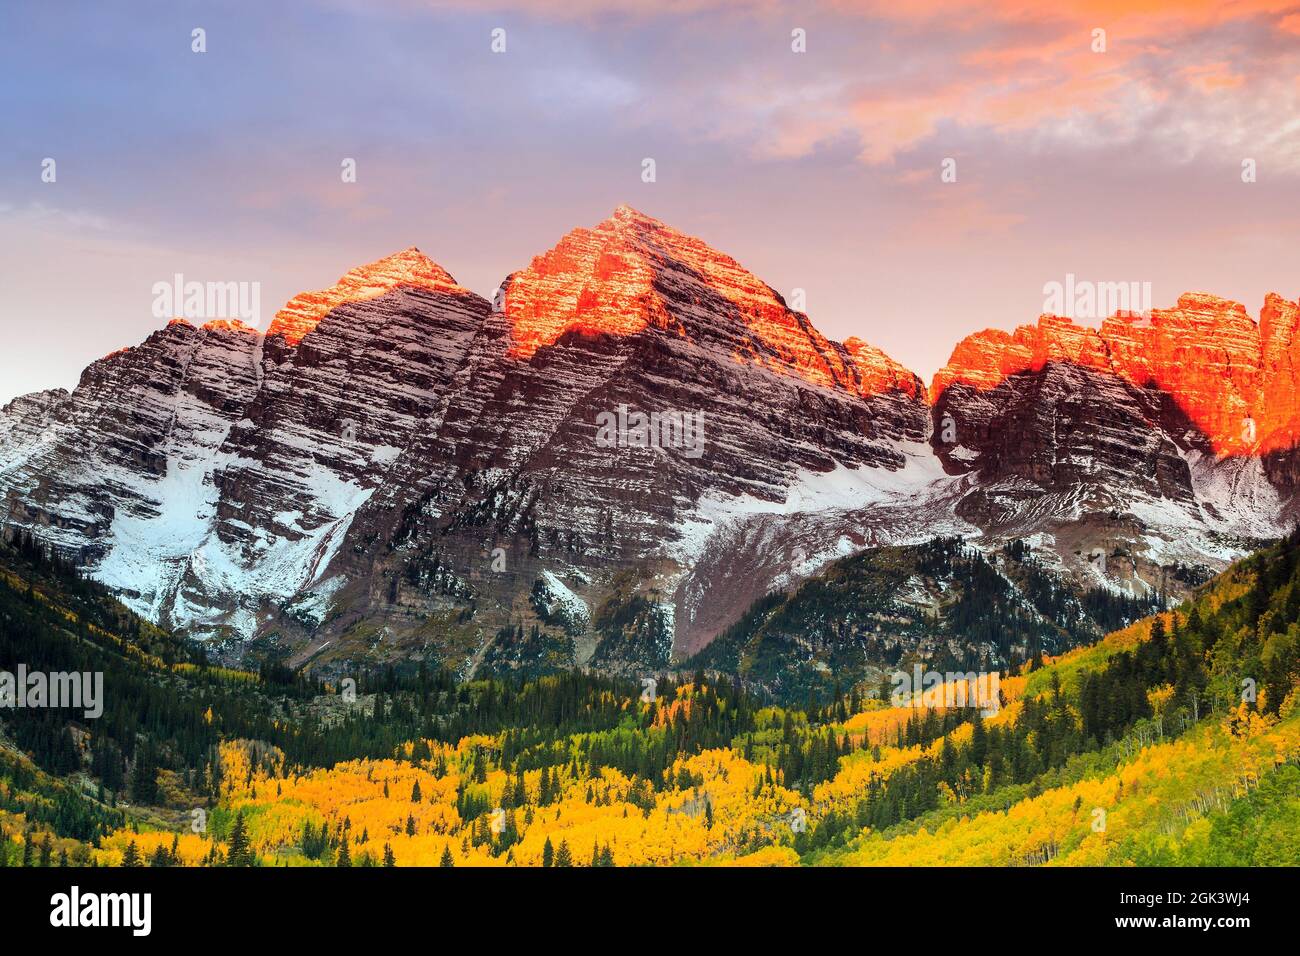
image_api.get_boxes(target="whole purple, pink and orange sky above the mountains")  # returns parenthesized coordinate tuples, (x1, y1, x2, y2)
(0, 0, 1300, 402)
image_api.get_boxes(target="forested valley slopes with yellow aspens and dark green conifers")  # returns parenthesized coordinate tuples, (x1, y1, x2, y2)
(0, 535, 1300, 866)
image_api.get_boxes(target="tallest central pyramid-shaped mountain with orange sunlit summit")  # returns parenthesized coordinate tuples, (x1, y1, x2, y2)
(317, 208, 927, 663)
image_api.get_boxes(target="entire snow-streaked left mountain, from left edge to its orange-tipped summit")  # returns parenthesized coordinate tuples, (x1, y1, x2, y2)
(0, 250, 488, 637)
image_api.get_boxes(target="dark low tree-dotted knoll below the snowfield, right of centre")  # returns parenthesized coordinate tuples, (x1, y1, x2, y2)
(688, 537, 1167, 700)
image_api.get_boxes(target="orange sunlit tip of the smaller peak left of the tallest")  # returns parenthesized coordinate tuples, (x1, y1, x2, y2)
(267, 246, 462, 345)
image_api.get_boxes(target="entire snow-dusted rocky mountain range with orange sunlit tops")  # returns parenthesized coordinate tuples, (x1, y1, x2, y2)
(0, 207, 1300, 671)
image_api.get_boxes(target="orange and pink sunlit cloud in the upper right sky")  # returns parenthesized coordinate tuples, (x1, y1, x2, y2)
(712, 0, 1300, 165)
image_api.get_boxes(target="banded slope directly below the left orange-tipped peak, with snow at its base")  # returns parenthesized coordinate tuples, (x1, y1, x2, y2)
(179, 250, 488, 635)
